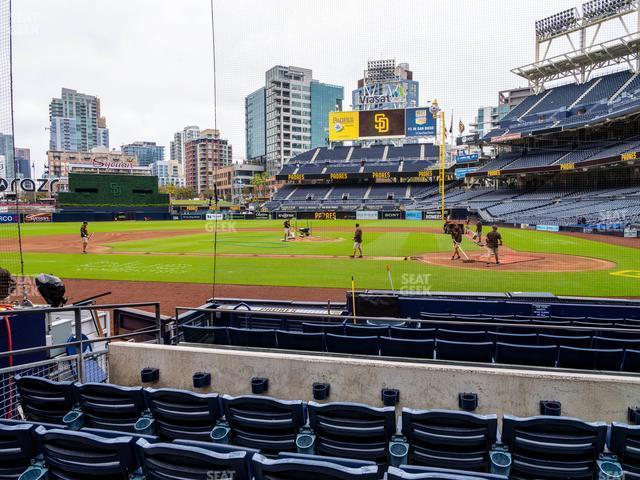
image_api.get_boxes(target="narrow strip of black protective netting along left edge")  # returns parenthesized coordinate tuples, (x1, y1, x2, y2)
(0, 0, 21, 296)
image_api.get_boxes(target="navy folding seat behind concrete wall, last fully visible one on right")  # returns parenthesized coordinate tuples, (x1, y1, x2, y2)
(502, 415, 607, 479)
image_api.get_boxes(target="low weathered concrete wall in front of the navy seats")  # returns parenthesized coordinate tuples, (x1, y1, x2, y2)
(109, 343, 640, 422)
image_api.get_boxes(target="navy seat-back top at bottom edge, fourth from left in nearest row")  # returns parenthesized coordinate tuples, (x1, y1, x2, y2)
(251, 453, 379, 480)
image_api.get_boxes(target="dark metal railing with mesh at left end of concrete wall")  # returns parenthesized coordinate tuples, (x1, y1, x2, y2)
(0, 302, 164, 419)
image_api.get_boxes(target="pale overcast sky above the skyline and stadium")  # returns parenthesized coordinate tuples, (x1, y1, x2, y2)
(14, 0, 592, 172)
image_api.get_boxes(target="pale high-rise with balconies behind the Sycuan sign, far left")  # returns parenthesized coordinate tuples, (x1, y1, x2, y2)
(49, 88, 109, 152)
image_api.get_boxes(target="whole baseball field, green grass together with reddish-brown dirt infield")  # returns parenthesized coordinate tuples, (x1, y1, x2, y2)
(10, 220, 640, 297)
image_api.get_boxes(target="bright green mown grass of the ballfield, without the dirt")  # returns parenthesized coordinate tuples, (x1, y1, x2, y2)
(8, 220, 640, 297)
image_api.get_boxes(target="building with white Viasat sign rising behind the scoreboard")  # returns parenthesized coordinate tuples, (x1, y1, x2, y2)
(351, 60, 420, 110)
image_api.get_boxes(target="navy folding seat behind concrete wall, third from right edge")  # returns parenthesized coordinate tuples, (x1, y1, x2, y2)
(402, 408, 498, 472)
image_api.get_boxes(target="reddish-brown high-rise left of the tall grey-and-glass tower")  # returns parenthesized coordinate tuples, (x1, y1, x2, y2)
(184, 129, 233, 193)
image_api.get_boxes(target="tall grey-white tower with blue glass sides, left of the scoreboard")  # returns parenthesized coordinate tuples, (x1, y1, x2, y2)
(245, 65, 344, 175)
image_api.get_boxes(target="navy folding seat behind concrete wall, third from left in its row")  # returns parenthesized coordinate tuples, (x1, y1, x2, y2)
(144, 388, 222, 441)
